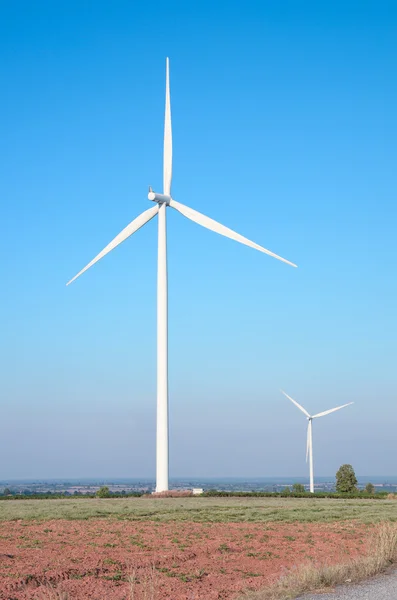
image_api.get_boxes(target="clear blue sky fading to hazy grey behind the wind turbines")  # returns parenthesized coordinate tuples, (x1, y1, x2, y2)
(0, 0, 397, 479)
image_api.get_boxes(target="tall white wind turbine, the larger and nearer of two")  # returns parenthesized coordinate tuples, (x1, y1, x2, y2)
(66, 58, 296, 492)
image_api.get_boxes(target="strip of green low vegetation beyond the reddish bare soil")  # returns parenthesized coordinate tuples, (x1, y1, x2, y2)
(0, 498, 397, 523)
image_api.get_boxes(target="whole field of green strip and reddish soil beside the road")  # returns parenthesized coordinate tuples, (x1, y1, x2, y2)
(0, 498, 397, 600)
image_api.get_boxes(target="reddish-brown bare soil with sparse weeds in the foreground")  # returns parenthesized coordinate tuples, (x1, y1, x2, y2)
(0, 520, 368, 600)
